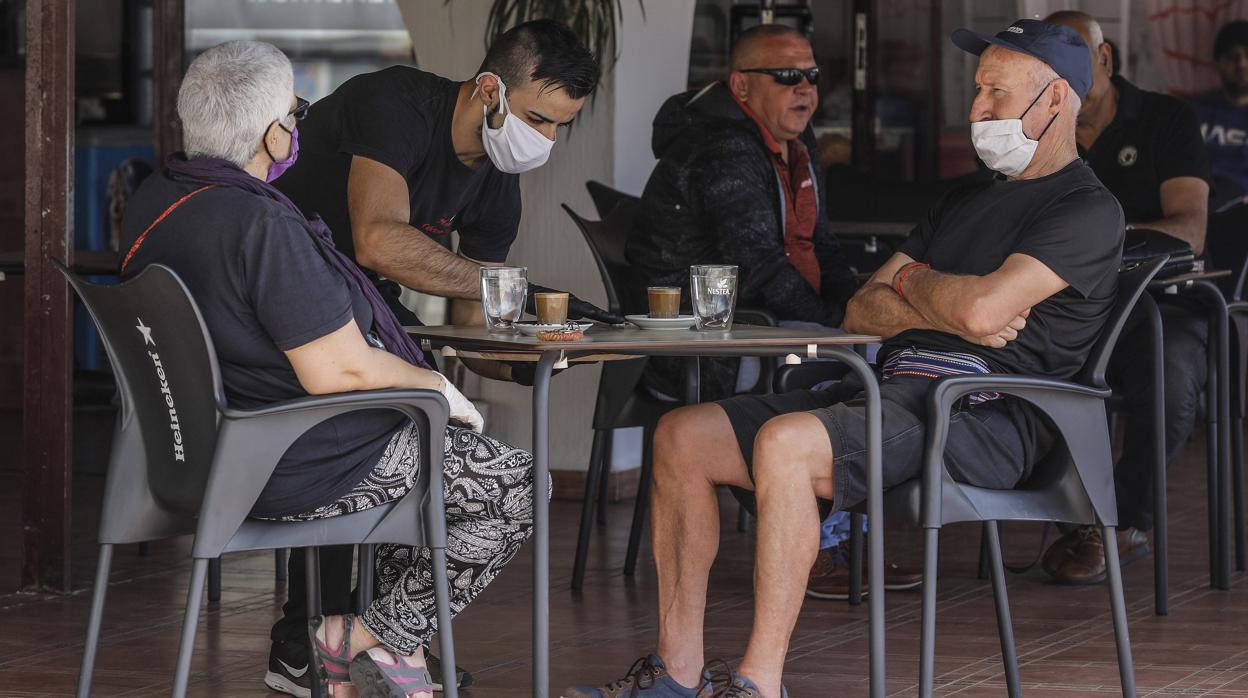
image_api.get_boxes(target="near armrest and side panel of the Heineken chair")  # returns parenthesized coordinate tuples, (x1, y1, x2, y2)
(195, 390, 449, 557)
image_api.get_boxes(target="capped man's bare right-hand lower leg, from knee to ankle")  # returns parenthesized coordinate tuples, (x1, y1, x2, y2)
(739, 413, 834, 698)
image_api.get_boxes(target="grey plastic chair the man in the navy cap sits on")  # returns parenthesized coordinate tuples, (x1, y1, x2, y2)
(776, 257, 1166, 698)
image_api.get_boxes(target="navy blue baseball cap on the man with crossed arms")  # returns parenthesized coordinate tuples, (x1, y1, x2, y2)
(950, 20, 1092, 100)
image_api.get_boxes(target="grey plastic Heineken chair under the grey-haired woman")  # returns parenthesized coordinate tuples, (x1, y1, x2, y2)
(54, 260, 458, 697)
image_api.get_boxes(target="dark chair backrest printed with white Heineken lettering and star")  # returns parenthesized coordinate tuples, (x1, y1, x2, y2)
(54, 260, 226, 514)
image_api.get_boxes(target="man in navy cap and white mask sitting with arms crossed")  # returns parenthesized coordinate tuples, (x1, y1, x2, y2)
(563, 20, 1123, 698)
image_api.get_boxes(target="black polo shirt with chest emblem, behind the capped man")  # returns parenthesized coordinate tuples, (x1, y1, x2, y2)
(1080, 75, 1209, 222)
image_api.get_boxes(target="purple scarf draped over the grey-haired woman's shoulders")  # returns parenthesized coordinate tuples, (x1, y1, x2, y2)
(165, 152, 432, 368)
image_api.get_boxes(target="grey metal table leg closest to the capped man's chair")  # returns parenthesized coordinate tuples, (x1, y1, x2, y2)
(819, 346, 885, 698)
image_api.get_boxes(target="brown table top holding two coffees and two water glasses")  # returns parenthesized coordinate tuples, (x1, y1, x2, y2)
(404, 325, 880, 353)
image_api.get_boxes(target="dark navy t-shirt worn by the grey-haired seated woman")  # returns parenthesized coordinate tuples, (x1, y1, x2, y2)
(121, 174, 404, 517)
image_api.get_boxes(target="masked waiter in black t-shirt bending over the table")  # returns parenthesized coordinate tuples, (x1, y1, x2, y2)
(266, 20, 609, 696)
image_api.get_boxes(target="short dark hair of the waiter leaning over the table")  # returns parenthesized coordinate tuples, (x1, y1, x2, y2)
(477, 20, 602, 100)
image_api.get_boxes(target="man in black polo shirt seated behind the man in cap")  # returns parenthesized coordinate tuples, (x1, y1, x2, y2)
(1043, 11, 1209, 584)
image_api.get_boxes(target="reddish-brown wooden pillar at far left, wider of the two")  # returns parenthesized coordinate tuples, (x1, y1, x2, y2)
(21, 0, 74, 592)
